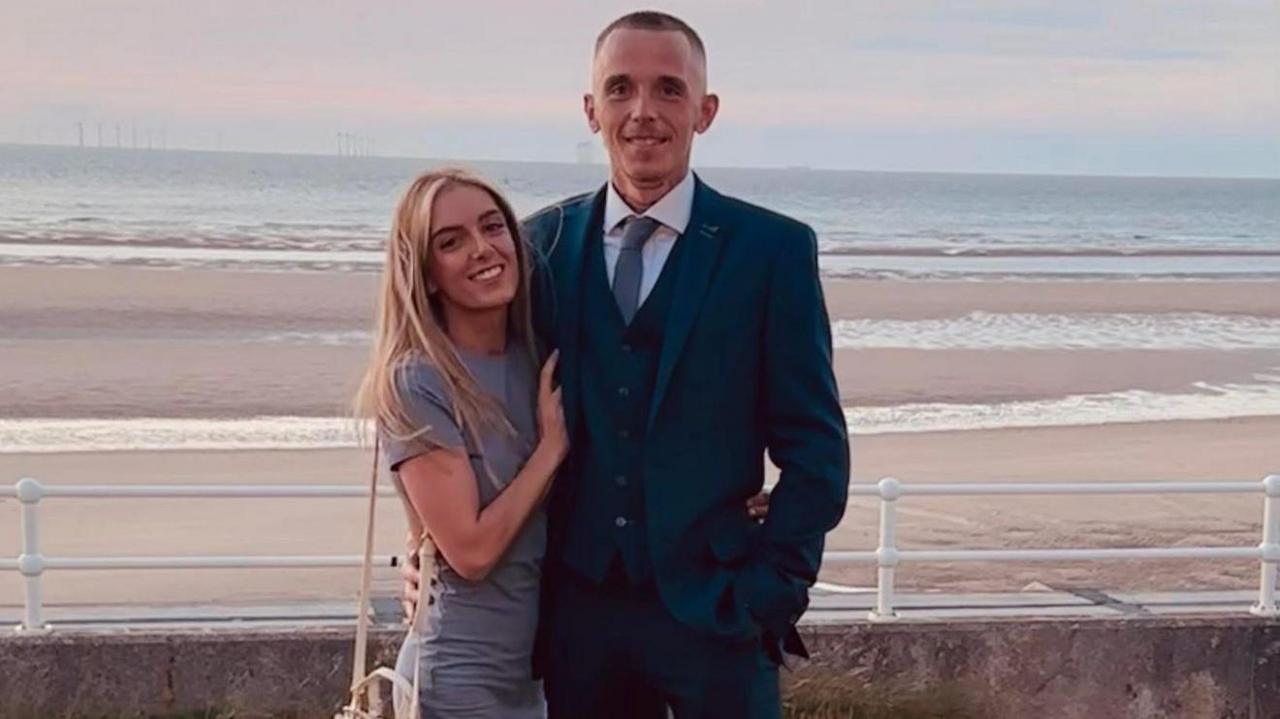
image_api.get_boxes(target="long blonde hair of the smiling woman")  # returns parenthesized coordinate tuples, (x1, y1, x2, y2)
(355, 168, 538, 441)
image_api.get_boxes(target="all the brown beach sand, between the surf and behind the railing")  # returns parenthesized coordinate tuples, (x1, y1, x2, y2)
(0, 267, 1280, 606)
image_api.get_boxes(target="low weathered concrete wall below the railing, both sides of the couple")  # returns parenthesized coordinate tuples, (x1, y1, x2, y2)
(0, 617, 1280, 719)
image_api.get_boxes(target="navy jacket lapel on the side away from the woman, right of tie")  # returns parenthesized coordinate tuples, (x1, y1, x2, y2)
(648, 175, 727, 429)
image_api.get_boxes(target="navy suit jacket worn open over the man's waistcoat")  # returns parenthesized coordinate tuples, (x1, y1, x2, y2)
(524, 179, 850, 652)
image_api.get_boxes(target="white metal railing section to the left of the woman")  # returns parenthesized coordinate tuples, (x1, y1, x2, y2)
(0, 477, 396, 632)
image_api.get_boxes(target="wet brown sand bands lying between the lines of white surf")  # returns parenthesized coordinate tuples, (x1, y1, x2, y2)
(0, 267, 1280, 417)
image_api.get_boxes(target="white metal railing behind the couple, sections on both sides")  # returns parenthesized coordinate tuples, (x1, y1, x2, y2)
(0, 475, 1280, 632)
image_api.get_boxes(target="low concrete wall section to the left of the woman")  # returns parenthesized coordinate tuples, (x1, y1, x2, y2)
(0, 628, 401, 719)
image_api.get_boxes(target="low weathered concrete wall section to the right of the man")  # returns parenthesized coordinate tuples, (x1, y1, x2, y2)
(808, 617, 1280, 719)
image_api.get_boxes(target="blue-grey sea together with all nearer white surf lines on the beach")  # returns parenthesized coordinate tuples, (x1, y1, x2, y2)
(0, 145, 1280, 452)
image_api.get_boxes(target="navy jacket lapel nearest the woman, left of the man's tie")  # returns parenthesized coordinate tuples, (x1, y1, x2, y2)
(554, 189, 604, 429)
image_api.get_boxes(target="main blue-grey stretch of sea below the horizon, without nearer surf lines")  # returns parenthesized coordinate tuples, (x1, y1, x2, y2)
(0, 145, 1280, 279)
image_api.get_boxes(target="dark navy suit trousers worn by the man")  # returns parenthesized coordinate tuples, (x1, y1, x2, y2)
(543, 567, 782, 719)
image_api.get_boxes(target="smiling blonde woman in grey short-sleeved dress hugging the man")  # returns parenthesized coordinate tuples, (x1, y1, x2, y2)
(357, 165, 558, 718)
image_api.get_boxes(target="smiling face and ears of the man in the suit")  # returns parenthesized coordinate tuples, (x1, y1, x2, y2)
(584, 28, 719, 189)
